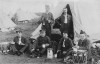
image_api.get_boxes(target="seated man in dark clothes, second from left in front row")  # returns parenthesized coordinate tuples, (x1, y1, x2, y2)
(32, 30, 50, 57)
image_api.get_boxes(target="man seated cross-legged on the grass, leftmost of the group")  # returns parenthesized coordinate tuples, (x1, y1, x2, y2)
(13, 31, 28, 56)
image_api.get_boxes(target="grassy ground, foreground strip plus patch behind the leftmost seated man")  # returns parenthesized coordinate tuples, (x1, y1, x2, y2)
(0, 22, 61, 64)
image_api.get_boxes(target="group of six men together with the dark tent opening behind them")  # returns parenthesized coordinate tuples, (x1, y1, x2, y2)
(8, 5, 92, 61)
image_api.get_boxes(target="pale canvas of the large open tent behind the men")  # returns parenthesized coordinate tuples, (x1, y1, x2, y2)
(31, 0, 100, 39)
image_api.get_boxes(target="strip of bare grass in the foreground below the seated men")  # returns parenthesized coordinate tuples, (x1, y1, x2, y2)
(0, 54, 61, 64)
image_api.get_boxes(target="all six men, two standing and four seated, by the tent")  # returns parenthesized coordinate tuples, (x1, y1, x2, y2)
(9, 5, 90, 62)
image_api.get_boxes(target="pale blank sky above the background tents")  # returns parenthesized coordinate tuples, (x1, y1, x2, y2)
(0, 0, 59, 13)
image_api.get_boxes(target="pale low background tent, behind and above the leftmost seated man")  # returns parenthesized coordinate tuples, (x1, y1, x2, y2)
(14, 9, 39, 21)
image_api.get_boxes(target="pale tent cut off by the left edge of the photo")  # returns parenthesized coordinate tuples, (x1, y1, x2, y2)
(0, 11, 16, 32)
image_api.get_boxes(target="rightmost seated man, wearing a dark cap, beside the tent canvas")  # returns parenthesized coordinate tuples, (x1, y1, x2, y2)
(78, 31, 92, 60)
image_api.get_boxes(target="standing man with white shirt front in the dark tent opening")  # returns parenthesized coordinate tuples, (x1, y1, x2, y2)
(59, 8, 71, 36)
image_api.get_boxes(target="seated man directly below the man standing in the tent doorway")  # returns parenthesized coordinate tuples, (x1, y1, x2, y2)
(57, 32, 73, 58)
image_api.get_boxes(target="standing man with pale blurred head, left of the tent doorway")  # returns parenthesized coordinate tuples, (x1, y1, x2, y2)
(40, 5, 54, 38)
